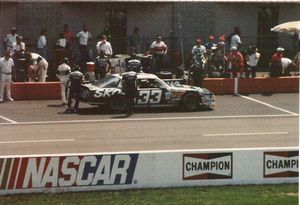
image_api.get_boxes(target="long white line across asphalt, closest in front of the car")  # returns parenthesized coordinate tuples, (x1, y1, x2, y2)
(0, 114, 299, 126)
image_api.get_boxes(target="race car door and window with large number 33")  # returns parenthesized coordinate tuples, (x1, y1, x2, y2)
(136, 79, 165, 106)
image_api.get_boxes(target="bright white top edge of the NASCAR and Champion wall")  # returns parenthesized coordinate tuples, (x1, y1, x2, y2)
(0, 147, 299, 160)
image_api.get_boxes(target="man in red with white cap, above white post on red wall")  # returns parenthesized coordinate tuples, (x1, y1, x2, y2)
(227, 46, 244, 78)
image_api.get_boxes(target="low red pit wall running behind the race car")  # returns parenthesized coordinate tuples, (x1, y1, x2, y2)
(12, 76, 300, 100)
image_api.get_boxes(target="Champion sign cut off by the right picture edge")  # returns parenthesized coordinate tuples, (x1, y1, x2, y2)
(264, 151, 299, 178)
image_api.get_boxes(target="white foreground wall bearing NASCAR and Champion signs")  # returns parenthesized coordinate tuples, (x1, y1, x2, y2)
(0, 147, 299, 195)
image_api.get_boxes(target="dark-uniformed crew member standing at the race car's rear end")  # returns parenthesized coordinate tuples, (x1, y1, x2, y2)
(65, 65, 84, 113)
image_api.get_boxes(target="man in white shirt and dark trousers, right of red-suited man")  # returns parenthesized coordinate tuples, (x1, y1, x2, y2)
(245, 46, 260, 78)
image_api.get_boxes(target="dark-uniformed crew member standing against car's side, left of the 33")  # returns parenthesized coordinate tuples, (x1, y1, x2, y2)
(122, 71, 137, 116)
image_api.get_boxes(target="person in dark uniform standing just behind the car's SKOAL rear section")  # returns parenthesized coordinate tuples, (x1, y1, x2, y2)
(95, 50, 110, 80)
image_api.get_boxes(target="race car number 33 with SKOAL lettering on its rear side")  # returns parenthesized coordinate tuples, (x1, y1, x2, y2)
(72, 73, 215, 111)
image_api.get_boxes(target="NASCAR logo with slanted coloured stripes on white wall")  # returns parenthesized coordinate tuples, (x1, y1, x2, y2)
(0, 154, 138, 190)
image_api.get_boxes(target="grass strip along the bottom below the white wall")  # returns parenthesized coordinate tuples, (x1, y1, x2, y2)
(0, 184, 298, 205)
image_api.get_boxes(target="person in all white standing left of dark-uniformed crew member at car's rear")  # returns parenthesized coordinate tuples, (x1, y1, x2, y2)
(56, 58, 71, 105)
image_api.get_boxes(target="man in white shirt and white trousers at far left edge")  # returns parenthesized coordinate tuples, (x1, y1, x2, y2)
(0, 51, 15, 103)
